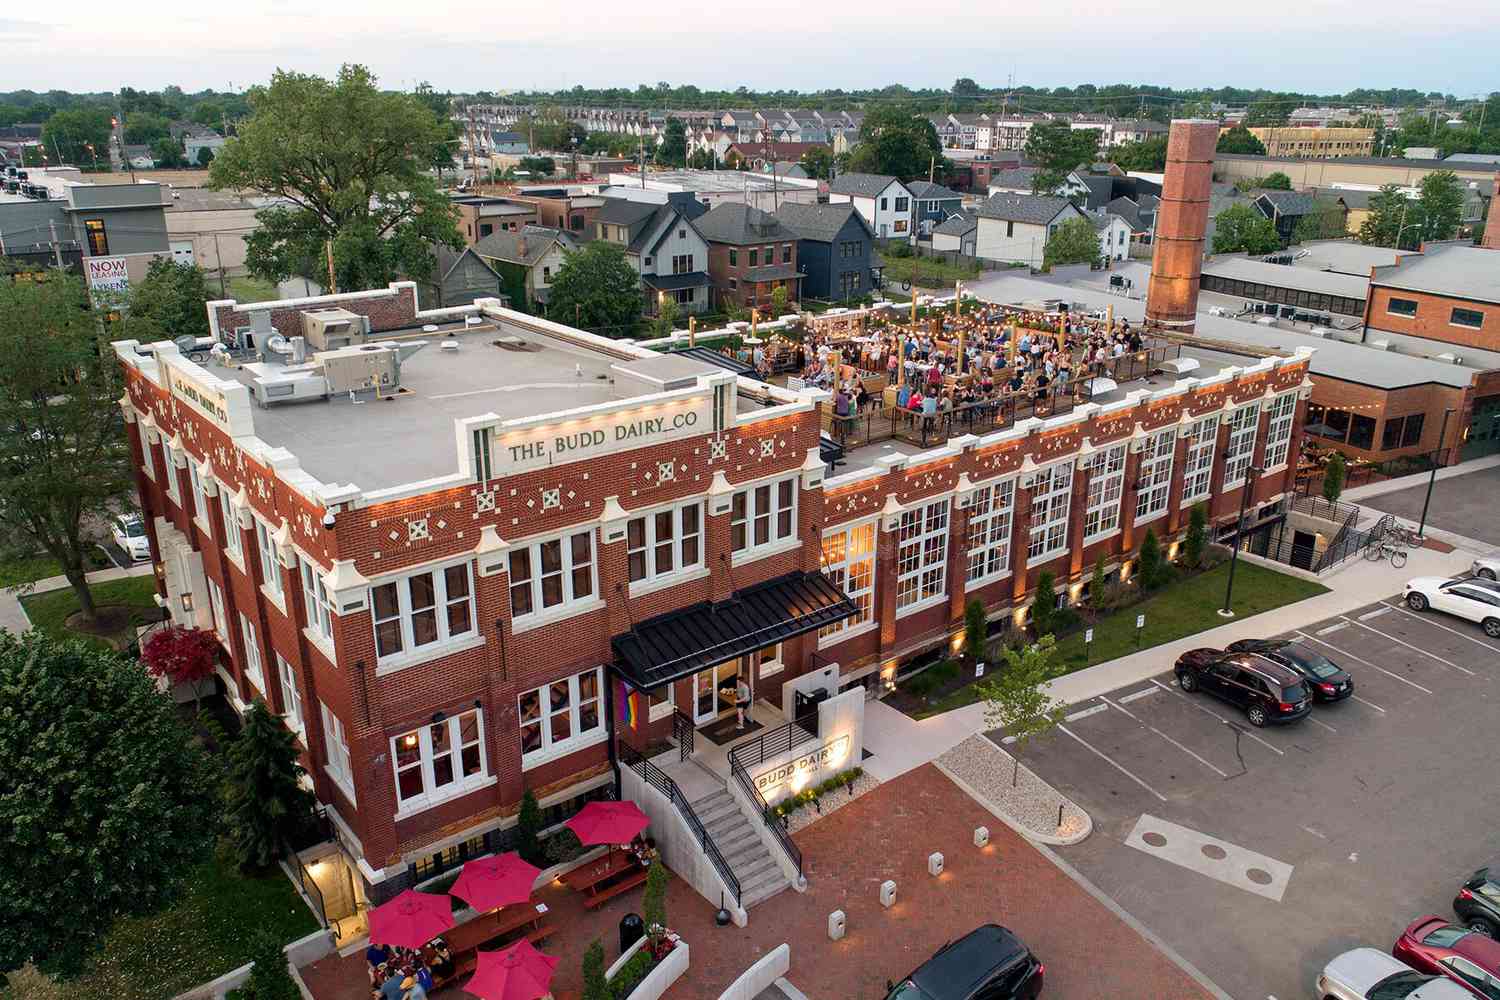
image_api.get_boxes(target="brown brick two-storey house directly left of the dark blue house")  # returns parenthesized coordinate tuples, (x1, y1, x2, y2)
(696, 202, 803, 307)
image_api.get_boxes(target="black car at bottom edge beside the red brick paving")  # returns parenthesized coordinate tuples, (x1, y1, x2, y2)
(885, 924, 1046, 1000)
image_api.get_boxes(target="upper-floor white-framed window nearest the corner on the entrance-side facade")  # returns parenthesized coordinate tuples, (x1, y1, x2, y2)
(371, 561, 474, 658)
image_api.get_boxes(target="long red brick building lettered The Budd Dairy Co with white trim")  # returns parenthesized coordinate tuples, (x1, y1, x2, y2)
(116, 283, 1308, 903)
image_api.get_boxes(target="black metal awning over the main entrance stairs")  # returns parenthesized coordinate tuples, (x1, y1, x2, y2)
(614, 573, 860, 690)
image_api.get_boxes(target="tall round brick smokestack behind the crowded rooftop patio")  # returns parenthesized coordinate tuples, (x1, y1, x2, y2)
(1146, 118, 1220, 333)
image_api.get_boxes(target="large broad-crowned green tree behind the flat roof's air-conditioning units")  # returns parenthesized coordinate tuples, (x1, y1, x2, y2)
(209, 64, 464, 291)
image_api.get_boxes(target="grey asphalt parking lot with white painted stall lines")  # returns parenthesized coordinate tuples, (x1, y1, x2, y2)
(1002, 595, 1500, 1000)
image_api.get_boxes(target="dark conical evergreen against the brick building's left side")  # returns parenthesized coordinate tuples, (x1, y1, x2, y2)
(225, 700, 317, 868)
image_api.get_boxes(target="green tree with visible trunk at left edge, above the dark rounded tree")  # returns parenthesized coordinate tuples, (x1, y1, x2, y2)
(0, 274, 144, 619)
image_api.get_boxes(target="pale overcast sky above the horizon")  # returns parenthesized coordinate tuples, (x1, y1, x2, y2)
(0, 0, 1500, 97)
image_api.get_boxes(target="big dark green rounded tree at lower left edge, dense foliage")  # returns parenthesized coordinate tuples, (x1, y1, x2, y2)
(0, 632, 216, 969)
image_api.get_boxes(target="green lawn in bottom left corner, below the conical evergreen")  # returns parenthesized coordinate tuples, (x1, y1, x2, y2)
(63, 850, 318, 1000)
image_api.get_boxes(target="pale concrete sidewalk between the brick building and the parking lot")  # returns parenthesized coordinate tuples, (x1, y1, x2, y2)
(864, 527, 1476, 781)
